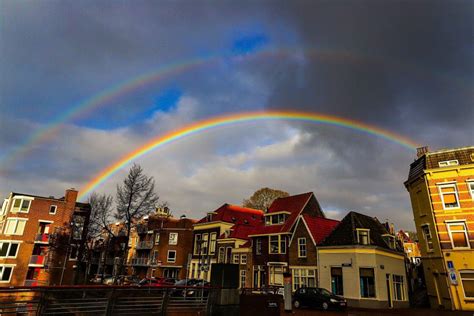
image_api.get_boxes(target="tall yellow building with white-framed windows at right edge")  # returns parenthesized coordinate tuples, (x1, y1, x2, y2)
(405, 146, 474, 311)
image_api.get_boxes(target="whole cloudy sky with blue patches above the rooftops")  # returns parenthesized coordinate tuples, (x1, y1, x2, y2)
(0, 0, 474, 229)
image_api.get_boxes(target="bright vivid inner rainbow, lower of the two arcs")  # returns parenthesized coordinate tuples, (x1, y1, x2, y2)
(79, 111, 419, 198)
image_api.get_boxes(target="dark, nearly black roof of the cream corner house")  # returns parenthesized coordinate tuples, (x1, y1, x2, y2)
(320, 212, 402, 249)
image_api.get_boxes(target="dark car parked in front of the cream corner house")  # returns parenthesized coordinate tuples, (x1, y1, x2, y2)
(293, 287, 347, 310)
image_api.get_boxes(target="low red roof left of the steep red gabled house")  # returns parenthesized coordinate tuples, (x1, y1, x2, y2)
(197, 203, 263, 226)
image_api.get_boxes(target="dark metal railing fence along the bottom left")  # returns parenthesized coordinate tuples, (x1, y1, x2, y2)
(0, 286, 213, 316)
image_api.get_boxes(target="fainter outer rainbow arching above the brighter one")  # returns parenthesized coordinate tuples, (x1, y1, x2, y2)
(0, 47, 444, 167)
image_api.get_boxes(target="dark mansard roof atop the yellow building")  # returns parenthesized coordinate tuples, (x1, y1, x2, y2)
(405, 146, 474, 186)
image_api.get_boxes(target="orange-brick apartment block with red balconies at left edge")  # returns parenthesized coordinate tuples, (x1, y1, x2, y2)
(0, 189, 90, 286)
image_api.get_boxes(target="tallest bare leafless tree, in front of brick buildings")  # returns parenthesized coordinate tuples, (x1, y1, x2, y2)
(114, 164, 159, 274)
